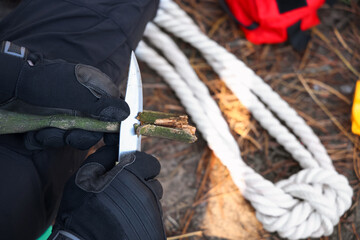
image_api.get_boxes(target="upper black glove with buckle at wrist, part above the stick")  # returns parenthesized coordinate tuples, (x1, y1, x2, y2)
(0, 41, 130, 122)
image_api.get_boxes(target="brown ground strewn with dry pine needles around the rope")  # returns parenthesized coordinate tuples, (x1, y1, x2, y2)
(140, 0, 360, 240)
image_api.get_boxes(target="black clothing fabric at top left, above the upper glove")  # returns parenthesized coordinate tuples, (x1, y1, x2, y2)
(0, 0, 159, 83)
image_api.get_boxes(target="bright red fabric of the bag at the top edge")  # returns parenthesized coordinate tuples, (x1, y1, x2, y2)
(226, 0, 325, 44)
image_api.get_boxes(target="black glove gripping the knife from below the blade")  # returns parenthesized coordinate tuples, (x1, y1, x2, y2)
(49, 146, 166, 240)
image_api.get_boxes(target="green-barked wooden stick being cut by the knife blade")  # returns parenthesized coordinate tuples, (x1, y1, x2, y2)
(0, 110, 197, 143)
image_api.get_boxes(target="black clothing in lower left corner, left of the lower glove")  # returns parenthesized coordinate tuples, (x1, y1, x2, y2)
(0, 133, 95, 240)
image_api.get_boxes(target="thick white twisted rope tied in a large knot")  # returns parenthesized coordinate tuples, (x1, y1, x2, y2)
(136, 0, 352, 239)
